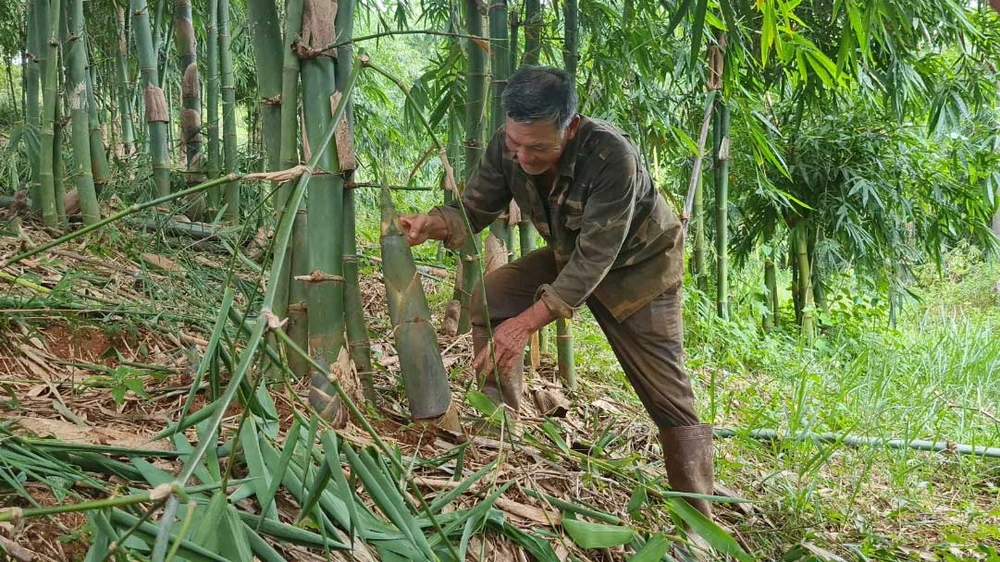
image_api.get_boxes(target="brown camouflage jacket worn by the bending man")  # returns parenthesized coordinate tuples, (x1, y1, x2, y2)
(431, 117, 684, 321)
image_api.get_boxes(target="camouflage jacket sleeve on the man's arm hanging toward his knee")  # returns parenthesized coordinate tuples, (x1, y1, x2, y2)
(537, 155, 639, 318)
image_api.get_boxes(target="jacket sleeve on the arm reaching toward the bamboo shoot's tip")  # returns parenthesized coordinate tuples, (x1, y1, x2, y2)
(430, 129, 513, 250)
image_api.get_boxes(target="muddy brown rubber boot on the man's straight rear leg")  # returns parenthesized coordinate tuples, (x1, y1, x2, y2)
(660, 423, 715, 519)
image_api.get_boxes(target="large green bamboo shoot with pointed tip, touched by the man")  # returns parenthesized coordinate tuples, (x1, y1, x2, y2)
(381, 188, 451, 420)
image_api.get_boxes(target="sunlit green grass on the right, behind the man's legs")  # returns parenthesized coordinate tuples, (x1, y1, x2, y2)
(560, 249, 1000, 560)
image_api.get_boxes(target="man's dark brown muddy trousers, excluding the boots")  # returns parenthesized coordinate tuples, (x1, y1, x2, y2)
(472, 248, 699, 429)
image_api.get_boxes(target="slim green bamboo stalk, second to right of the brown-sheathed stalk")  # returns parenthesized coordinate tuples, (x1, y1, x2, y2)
(218, 0, 240, 222)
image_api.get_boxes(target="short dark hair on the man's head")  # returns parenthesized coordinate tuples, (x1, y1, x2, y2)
(502, 65, 576, 130)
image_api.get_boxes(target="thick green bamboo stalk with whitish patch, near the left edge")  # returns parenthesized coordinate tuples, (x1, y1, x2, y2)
(66, 0, 103, 224)
